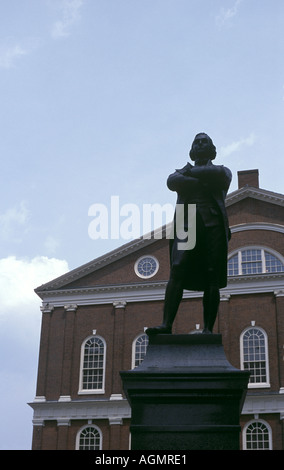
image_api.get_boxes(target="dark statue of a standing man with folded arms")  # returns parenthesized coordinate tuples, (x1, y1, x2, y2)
(146, 133, 232, 335)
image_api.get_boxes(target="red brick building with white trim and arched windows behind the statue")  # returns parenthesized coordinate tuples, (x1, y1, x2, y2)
(30, 170, 284, 450)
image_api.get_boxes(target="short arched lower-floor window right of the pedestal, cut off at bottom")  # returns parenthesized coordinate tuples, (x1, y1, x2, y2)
(243, 420, 272, 450)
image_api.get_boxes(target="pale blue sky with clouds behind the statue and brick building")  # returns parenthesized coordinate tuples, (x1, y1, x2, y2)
(0, 0, 284, 450)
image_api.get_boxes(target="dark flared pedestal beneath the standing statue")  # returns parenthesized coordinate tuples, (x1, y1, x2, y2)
(121, 334, 249, 450)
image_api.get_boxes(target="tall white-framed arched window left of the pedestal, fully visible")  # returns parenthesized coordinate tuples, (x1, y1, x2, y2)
(79, 336, 106, 393)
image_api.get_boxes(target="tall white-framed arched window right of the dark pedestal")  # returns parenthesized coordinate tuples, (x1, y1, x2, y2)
(240, 327, 270, 388)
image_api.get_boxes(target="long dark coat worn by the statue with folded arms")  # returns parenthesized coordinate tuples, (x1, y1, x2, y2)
(167, 160, 232, 291)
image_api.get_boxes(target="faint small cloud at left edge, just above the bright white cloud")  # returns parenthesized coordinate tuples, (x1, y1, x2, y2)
(0, 201, 31, 241)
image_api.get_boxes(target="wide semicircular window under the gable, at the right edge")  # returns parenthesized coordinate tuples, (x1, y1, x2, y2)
(228, 247, 284, 276)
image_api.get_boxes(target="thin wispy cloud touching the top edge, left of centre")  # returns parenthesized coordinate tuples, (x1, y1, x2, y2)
(51, 0, 84, 39)
